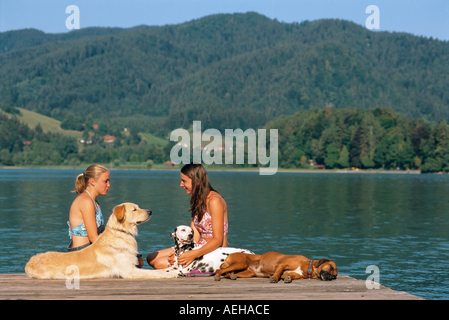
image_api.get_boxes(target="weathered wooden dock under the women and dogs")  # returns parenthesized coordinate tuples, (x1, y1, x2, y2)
(0, 274, 422, 301)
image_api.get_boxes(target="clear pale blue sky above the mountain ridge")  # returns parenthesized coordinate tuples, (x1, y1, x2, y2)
(0, 0, 449, 41)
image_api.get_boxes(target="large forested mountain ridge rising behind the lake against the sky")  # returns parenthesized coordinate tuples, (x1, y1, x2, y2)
(0, 13, 449, 134)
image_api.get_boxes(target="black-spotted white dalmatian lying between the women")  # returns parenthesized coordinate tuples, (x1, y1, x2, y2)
(166, 225, 254, 275)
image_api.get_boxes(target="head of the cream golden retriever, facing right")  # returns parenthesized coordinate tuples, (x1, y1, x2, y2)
(108, 202, 151, 235)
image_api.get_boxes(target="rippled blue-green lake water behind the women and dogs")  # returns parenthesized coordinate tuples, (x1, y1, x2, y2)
(0, 169, 449, 299)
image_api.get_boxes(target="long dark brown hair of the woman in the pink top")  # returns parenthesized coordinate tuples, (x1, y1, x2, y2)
(181, 163, 218, 222)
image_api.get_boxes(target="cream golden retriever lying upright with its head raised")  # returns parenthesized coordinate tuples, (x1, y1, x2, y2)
(25, 203, 178, 279)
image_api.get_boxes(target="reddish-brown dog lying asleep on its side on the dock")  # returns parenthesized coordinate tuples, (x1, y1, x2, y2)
(215, 252, 338, 283)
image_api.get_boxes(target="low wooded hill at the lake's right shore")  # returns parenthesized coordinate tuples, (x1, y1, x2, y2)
(267, 108, 449, 172)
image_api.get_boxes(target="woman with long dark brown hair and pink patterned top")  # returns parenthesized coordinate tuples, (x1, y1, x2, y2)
(147, 164, 228, 269)
